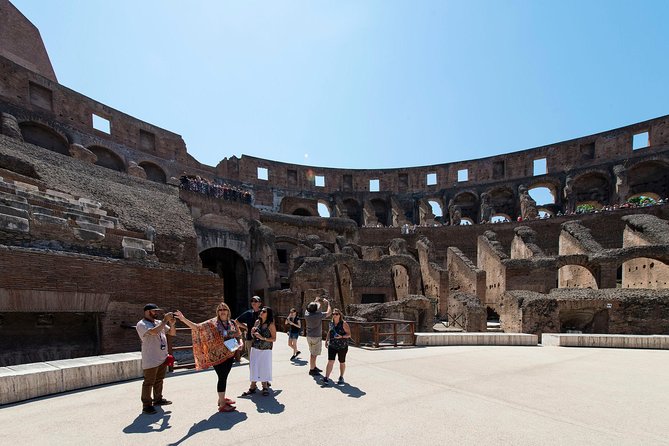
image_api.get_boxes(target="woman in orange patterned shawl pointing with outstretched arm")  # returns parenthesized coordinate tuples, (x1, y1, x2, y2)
(175, 302, 244, 412)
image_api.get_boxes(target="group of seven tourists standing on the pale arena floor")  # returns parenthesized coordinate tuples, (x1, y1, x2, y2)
(136, 296, 351, 414)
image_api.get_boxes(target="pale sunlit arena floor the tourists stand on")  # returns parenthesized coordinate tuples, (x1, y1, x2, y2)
(0, 333, 669, 446)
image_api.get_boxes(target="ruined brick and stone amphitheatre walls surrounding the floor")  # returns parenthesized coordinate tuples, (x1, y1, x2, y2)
(0, 0, 669, 365)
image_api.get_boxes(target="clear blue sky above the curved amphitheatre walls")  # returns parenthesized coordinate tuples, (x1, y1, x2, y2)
(12, 0, 669, 168)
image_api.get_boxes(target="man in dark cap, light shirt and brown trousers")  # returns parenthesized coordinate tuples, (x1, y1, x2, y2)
(135, 304, 176, 414)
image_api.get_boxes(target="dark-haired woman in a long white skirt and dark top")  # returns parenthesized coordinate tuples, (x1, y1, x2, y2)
(242, 307, 276, 396)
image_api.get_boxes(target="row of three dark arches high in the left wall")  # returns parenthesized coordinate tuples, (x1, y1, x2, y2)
(19, 121, 167, 183)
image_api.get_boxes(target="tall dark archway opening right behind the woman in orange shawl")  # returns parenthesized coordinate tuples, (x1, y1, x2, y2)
(200, 248, 250, 316)
